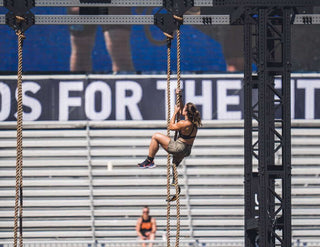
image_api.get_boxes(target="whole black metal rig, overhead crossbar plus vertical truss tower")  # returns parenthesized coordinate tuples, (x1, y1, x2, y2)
(0, 0, 320, 247)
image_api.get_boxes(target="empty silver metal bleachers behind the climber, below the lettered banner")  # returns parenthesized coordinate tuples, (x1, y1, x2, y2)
(0, 121, 320, 246)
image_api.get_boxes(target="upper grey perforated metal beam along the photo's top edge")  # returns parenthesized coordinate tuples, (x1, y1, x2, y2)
(0, 0, 212, 7)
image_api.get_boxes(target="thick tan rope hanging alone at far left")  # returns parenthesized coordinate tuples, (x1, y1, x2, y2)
(14, 26, 25, 247)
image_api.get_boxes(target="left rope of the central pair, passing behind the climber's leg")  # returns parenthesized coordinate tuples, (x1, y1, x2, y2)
(167, 36, 171, 247)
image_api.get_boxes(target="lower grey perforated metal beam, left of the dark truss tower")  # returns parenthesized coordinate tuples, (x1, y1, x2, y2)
(0, 15, 230, 25)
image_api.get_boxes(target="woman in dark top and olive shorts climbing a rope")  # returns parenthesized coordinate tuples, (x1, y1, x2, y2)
(138, 90, 201, 168)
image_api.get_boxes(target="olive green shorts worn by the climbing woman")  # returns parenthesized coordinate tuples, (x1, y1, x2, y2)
(168, 139, 192, 165)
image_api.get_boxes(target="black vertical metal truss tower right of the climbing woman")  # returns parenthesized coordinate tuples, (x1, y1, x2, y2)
(244, 7, 293, 247)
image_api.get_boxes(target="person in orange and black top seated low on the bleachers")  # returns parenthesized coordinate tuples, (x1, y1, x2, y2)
(136, 206, 157, 247)
